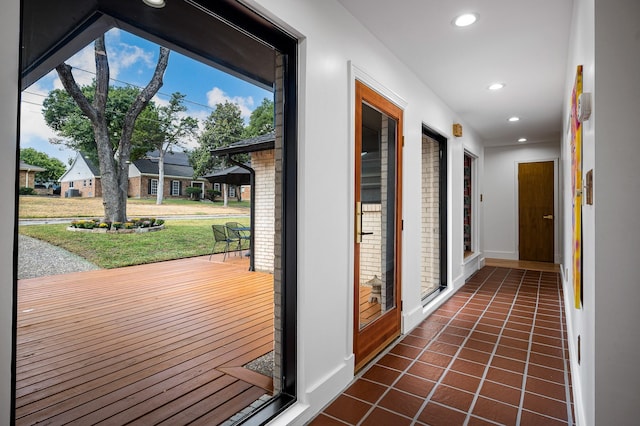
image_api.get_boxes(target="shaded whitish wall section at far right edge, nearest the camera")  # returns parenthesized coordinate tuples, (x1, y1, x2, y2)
(585, 0, 640, 425)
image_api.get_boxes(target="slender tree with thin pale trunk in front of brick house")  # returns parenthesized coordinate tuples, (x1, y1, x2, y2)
(147, 92, 198, 204)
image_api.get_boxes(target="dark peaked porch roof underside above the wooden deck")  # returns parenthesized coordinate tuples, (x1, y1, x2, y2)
(21, 0, 281, 90)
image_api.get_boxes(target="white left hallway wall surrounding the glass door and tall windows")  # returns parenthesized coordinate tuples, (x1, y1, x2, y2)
(246, 0, 482, 424)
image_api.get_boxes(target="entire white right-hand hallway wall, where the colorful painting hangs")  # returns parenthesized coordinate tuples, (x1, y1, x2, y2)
(563, 0, 640, 425)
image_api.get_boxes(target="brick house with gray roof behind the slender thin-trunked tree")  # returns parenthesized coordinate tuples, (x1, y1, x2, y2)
(129, 151, 211, 198)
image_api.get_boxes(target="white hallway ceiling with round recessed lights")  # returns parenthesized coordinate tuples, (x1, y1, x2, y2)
(338, 0, 573, 146)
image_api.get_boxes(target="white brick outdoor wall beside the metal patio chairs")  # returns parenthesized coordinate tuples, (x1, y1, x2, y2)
(251, 150, 276, 273)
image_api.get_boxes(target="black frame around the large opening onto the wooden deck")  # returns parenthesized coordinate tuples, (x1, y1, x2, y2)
(16, 0, 300, 424)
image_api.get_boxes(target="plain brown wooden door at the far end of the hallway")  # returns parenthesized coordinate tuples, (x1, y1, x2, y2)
(518, 161, 555, 262)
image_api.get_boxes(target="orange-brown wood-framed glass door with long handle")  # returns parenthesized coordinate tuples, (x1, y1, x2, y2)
(354, 81, 402, 370)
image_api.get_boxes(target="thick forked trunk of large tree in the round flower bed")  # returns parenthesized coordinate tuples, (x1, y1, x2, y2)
(46, 35, 169, 222)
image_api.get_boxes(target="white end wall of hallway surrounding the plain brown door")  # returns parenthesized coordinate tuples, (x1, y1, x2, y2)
(481, 142, 562, 262)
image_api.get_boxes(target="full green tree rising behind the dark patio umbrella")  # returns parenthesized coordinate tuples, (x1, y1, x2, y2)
(190, 101, 244, 177)
